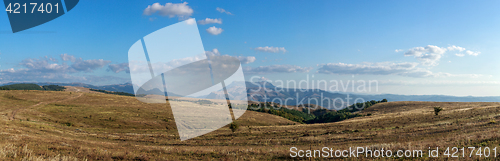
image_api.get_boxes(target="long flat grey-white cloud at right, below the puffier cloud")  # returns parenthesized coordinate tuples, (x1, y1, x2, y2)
(317, 62, 479, 78)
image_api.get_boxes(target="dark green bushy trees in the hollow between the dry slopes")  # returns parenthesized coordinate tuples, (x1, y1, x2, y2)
(248, 99, 387, 124)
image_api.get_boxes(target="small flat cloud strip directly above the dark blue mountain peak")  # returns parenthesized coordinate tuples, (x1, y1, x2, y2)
(243, 65, 312, 74)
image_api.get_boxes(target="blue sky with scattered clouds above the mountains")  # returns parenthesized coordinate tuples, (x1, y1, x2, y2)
(0, 0, 500, 96)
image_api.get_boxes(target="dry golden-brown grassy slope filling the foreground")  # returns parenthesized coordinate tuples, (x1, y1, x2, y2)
(0, 91, 500, 160)
